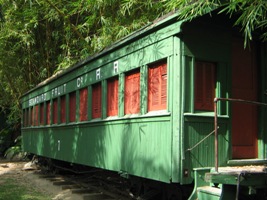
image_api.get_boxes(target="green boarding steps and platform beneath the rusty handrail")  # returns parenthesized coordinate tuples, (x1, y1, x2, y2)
(189, 165, 267, 200)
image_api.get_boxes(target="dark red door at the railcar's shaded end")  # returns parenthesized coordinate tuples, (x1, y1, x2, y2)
(232, 38, 258, 159)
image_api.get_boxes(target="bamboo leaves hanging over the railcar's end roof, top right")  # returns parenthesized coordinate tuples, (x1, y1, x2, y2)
(165, 0, 267, 46)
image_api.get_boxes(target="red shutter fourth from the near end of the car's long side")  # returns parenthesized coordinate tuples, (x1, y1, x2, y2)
(92, 83, 102, 119)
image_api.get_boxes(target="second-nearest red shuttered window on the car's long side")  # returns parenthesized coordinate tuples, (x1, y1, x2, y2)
(124, 70, 140, 114)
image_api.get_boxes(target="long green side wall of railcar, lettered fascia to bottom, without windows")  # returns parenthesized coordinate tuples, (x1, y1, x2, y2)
(22, 16, 184, 182)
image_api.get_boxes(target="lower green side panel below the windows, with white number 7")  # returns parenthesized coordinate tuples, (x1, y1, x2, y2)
(23, 116, 172, 182)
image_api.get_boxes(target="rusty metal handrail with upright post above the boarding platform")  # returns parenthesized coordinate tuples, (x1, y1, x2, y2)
(214, 98, 267, 172)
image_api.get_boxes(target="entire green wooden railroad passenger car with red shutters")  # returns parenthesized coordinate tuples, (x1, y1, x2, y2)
(21, 10, 267, 199)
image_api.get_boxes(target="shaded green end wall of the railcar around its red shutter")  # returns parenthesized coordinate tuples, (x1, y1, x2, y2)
(180, 18, 231, 184)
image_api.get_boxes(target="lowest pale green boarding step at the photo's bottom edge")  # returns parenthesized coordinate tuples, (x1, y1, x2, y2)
(197, 186, 222, 200)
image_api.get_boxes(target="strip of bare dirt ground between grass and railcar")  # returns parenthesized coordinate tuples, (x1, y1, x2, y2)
(0, 159, 84, 200)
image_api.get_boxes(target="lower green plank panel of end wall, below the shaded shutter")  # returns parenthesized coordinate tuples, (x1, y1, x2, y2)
(183, 116, 231, 183)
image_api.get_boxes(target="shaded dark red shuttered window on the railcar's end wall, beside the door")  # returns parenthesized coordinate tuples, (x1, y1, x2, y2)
(195, 61, 215, 111)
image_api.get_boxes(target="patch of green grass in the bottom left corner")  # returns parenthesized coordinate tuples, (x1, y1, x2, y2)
(0, 178, 51, 200)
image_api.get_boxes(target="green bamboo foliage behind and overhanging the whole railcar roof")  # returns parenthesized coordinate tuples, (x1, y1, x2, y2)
(0, 0, 267, 126)
